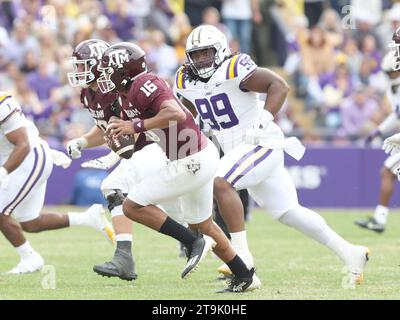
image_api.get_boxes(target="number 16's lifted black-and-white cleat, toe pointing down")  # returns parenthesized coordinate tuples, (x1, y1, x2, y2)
(181, 234, 216, 279)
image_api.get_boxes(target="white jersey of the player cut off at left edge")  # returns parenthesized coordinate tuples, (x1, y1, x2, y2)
(0, 91, 39, 165)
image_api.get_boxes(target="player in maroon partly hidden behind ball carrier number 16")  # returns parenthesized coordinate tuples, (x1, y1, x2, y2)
(67, 39, 137, 281)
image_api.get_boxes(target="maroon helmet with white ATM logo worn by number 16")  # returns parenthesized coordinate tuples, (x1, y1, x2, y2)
(97, 42, 147, 93)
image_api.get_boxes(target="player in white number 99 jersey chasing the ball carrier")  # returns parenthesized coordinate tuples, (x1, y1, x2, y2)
(174, 25, 369, 283)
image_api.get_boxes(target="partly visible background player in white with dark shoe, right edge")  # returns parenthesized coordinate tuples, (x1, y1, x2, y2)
(354, 52, 400, 233)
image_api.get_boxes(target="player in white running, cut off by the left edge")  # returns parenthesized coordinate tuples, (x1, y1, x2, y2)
(0, 92, 114, 274)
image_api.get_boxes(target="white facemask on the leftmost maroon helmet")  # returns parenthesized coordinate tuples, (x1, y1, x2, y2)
(67, 57, 97, 88)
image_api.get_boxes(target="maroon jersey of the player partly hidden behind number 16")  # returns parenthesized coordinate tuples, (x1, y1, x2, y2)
(81, 88, 121, 132)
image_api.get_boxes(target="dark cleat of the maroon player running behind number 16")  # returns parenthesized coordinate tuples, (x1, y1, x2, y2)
(93, 250, 137, 281)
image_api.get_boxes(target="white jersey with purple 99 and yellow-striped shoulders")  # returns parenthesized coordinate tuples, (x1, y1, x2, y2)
(174, 54, 283, 152)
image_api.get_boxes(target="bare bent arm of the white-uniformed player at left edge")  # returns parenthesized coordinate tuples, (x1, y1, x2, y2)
(3, 127, 30, 174)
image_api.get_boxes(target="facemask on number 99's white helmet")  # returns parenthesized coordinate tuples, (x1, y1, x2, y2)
(186, 43, 223, 79)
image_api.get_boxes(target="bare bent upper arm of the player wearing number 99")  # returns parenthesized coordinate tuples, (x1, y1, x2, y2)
(241, 68, 289, 116)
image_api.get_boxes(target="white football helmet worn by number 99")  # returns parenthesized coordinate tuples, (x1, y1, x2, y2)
(186, 25, 231, 78)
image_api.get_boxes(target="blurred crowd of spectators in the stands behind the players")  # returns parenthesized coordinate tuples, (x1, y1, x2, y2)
(0, 0, 400, 147)
